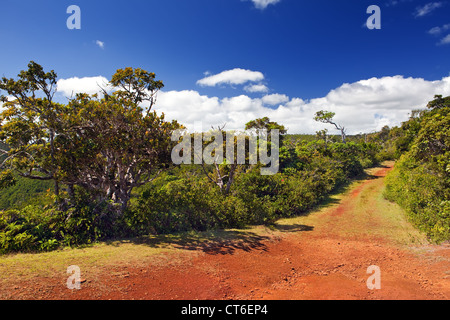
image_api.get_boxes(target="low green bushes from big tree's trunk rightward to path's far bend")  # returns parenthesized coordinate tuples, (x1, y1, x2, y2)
(123, 141, 375, 235)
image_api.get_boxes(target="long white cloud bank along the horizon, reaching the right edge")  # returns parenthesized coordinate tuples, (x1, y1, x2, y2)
(154, 76, 450, 134)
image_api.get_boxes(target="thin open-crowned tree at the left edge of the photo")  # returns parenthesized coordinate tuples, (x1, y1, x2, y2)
(0, 61, 62, 195)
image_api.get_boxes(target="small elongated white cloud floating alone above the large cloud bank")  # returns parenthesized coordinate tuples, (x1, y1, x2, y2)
(197, 68, 264, 87)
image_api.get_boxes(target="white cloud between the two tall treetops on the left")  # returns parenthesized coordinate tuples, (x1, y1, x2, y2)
(57, 76, 108, 97)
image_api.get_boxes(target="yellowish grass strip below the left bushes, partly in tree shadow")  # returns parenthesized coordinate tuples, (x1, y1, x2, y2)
(0, 226, 278, 285)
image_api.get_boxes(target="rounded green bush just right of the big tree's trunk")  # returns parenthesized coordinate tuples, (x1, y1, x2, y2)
(123, 177, 246, 236)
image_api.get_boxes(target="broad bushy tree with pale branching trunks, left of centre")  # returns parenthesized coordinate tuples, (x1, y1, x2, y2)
(57, 94, 179, 213)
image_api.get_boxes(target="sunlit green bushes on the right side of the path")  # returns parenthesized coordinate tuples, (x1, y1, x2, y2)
(385, 96, 450, 242)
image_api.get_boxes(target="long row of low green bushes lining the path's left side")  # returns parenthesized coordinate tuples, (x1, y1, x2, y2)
(0, 136, 390, 253)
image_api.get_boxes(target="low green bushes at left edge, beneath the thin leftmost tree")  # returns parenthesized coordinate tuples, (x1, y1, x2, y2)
(0, 190, 120, 253)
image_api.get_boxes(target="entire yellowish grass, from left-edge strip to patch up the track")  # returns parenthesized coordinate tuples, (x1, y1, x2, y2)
(0, 162, 426, 284)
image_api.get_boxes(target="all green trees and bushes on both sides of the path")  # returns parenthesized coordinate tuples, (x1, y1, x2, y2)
(0, 62, 450, 253)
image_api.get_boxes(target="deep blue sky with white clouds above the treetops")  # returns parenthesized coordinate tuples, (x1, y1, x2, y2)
(0, 0, 450, 133)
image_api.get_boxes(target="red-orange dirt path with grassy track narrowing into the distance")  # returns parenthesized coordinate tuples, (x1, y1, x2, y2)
(0, 164, 450, 300)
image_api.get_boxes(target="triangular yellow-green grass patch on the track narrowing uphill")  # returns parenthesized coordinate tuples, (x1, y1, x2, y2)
(277, 162, 427, 246)
